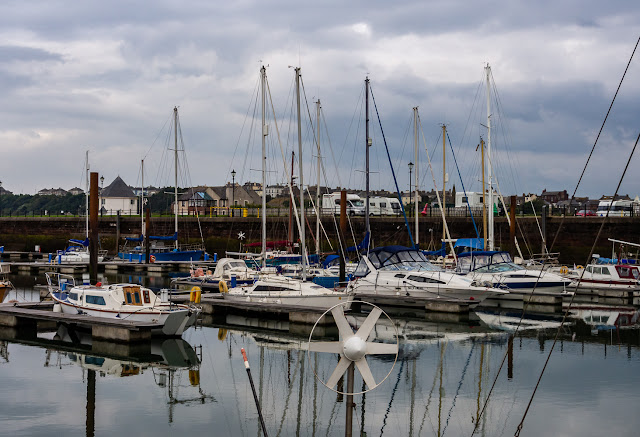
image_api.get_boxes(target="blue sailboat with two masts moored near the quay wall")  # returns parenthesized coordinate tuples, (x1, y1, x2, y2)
(118, 107, 204, 262)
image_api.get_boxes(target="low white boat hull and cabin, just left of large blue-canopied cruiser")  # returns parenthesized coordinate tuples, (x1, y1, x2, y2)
(220, 275, 353, 309)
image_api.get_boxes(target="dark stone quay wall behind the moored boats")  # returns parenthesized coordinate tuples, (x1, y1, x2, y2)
(0, 216, 640, 264)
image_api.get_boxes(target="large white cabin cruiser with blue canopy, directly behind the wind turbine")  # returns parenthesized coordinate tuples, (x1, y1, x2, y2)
(347, 246, 507, 305)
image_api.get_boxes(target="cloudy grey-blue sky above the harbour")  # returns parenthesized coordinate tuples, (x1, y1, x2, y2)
(0, 0, 640, 197)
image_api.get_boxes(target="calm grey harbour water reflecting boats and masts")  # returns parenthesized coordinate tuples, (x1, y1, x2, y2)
(0, 270, 640, 436)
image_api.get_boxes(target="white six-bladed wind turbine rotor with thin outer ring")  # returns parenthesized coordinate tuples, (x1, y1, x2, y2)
(307, 302, 398, 395)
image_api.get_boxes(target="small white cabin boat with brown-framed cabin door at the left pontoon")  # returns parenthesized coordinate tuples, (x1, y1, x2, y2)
(45, 273, 200, 336)
